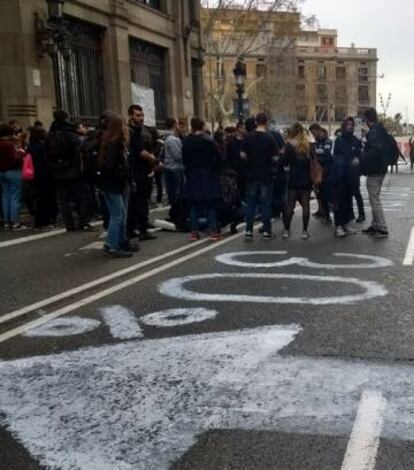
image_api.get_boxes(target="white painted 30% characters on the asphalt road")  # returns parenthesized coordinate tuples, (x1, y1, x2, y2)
(25, 251, 393, 340)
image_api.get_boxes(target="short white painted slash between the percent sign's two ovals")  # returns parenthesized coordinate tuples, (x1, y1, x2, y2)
(100, 305, 144, 339)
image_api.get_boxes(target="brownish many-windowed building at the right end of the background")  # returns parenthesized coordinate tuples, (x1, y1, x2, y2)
(296, 29, 378, 129)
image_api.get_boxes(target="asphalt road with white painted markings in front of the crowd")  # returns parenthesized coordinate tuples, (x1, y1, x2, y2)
(0, 170, 414, 470)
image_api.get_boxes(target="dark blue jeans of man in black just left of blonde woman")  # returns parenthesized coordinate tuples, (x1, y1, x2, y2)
(246, 181, 273, 233)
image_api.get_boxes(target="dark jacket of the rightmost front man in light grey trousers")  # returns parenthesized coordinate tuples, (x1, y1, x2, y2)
(360, 122, 388, 176)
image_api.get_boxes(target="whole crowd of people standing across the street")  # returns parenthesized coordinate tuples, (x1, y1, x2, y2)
(0, 105, 414, 258)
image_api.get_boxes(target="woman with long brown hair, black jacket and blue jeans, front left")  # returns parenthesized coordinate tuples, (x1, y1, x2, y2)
(98, 114, 135, 258)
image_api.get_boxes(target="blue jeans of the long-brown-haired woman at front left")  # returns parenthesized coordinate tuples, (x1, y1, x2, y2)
(102, 191, 127, 250)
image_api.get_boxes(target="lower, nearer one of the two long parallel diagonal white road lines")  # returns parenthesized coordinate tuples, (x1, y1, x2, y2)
(0, 228, 251, 343)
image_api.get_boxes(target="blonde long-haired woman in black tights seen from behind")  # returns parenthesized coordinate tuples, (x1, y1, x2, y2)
(283, 123, 312, 240)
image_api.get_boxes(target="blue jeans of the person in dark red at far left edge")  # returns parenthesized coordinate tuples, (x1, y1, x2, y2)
(0, 170, 22, 223)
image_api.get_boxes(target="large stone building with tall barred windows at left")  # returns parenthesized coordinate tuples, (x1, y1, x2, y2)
(0, 0, 203, 126)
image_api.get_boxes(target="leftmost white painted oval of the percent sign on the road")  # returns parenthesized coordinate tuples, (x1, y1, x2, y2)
(24, 317, 101, 337)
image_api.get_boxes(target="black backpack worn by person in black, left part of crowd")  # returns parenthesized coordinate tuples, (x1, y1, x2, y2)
(46, 130, 79, 173)
